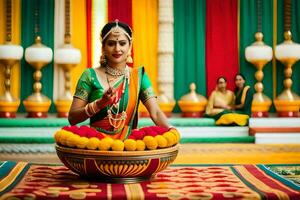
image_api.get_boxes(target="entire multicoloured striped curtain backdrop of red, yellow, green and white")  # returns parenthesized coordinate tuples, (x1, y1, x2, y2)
(0, 0, 300, 112)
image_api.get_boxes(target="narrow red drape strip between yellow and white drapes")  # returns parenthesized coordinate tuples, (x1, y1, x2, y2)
(86, 0, 92, 67)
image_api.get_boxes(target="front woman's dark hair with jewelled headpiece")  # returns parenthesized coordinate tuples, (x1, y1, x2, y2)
(101, 20, 132, 44)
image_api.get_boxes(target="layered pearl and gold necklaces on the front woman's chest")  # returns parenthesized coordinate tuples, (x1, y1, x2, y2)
(105, 66, 130, 131)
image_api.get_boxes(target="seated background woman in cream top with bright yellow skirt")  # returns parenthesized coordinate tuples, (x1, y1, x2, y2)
(205, 76, 249, 126)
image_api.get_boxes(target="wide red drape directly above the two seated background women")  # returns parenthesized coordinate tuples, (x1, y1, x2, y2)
(206, 0, 239, 95)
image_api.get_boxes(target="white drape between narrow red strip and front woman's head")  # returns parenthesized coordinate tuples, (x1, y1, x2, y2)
(89, 0, 107, 67)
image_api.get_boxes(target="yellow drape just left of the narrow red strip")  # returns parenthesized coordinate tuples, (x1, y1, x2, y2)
(71, 0, 87, 94)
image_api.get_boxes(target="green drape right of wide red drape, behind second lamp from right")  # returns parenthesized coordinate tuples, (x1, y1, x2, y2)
(239, 0, 273, 105)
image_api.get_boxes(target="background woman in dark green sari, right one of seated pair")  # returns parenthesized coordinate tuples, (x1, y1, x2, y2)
(232, 74, 253, 116)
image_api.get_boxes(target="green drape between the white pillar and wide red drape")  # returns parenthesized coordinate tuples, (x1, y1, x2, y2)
(173, 0, 206, 112)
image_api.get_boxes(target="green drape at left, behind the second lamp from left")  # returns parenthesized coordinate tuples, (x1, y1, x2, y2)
(19, 0, 55, 112)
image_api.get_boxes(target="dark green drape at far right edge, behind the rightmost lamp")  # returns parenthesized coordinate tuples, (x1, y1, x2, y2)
(276, 0, 300, 96)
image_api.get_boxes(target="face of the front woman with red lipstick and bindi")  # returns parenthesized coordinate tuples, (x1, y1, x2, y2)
(102, 33, 131, 67)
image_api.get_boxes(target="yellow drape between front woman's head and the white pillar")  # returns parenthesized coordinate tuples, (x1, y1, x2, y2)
(132, 0, 158, 91)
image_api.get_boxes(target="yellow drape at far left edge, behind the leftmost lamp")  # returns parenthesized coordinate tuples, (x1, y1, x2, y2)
(0, 0, 21, 98)
